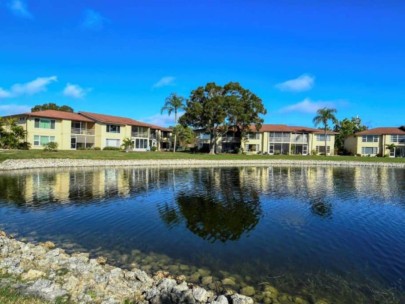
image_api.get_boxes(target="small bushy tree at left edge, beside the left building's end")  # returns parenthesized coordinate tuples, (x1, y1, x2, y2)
(0, 118, 27, 149)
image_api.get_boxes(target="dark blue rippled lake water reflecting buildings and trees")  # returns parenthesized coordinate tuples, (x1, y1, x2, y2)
(0, 166, 405, 303)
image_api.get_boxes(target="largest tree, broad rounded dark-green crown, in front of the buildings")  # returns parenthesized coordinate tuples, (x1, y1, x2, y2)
(180, 82, 266, 154)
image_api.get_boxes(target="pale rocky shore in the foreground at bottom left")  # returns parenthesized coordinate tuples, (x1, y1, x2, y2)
(0, 231, 254, 304)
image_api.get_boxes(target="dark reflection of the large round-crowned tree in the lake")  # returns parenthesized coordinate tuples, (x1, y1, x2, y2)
(159, 168, 262, 242)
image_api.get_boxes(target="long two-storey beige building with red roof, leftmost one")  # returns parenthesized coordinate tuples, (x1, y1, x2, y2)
(13, 110, 171, 151)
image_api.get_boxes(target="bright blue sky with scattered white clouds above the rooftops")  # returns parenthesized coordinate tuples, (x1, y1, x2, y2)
(0, 0, 405, 127)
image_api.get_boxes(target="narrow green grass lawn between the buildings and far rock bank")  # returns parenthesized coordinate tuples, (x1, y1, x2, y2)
(0, 150, 405, 163)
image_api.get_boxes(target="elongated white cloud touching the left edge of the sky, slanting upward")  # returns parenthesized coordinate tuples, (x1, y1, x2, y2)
(0, 76, 58, 98)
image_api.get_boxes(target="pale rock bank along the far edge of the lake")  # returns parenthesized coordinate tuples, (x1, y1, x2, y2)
(0, 159, 405, 171)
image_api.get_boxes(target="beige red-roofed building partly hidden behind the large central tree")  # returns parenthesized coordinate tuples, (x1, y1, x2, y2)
(198, 124, 337, 155)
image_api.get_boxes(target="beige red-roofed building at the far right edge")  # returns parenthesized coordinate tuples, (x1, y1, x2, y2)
(345, 126, 405, 157)
